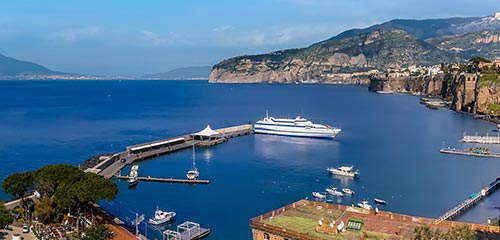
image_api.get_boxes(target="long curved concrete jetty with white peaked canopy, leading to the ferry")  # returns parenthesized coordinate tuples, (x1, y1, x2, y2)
(89, 124, 253, 178)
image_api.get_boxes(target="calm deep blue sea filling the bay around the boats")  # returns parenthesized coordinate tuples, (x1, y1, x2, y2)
(0, 81, 500, 239)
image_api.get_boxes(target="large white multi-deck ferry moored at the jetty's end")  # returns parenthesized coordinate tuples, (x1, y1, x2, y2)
(254, 112, 341, 139)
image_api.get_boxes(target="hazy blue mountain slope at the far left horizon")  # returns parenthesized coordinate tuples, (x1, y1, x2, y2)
(0, 54, 61, 76)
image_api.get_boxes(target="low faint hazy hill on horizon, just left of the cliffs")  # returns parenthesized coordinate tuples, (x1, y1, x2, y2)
(143, 66, 212, 79)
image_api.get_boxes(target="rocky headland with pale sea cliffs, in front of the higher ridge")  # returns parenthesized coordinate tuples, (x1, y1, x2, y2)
(209, 29, 451, 83)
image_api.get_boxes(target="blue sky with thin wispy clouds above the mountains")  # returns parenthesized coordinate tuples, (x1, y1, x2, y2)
(0, 0, 500, 76)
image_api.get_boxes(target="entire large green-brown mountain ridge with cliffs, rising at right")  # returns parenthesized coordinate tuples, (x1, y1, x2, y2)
(209, 13, 500, 83)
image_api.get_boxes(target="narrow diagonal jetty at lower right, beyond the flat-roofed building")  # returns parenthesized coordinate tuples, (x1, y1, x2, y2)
(434, 178, 500, 225)
